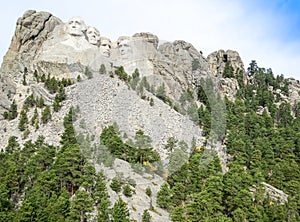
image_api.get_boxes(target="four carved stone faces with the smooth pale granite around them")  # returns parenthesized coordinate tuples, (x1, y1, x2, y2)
(38, 17, 162, 69)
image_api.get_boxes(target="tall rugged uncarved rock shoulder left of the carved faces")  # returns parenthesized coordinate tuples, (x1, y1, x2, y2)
(0, 10, 62, 117)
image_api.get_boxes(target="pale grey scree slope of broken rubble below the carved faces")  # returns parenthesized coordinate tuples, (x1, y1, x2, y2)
(69, 75, 204, 155)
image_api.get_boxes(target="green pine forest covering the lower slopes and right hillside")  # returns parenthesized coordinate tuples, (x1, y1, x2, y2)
(0, 61, 300, 222)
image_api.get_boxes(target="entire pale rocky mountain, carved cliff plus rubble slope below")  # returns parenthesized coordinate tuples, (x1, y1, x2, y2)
(0, 10, 300, 221)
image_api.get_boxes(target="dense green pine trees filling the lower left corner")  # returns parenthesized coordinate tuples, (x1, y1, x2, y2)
(0, 103, 111, 222)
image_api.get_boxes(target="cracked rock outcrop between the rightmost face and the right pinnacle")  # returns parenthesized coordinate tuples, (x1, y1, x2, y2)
(154, 40, 211, 100)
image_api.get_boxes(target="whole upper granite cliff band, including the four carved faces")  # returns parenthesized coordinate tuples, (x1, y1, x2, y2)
(1, 10, 244, 114)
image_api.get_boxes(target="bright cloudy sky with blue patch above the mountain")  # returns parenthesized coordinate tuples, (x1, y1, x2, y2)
(0, 0, 300, 80)
